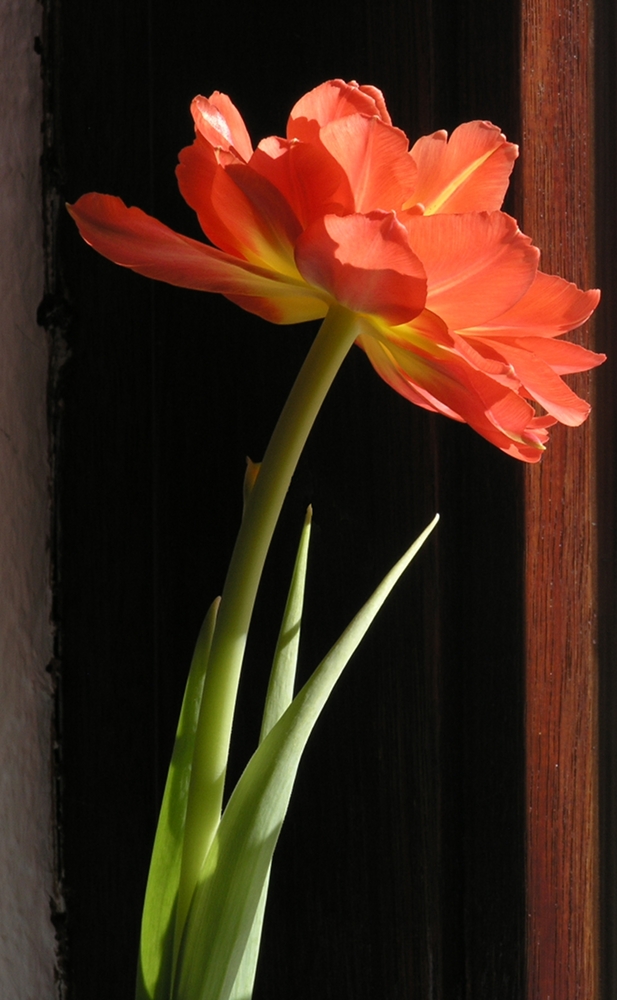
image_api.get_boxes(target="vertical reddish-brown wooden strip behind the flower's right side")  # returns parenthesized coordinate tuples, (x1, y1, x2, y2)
(521, 0, 599, 1000)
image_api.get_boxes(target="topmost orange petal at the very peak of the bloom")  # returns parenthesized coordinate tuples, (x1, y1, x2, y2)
(287, 80, 390, 142)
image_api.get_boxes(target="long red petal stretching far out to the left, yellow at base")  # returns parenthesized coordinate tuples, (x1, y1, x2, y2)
(67, 194, 328, 323)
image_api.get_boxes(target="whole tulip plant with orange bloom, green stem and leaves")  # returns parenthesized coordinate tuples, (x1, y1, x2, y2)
(69, 80, 604, 1000)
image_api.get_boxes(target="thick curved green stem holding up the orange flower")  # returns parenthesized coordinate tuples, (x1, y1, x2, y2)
(175, 306, 359, 953)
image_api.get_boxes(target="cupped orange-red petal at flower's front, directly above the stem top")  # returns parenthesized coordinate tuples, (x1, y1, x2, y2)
(296, 212, 426, 324)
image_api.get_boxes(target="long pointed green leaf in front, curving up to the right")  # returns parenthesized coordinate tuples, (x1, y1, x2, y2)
(173, 517, 438, 1000)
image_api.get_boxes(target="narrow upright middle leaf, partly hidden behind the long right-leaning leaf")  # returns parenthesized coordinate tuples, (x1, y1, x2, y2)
(230, 507, 313, 1000)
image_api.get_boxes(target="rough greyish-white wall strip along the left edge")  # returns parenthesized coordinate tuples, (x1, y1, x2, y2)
(0, 0, 56, 1000)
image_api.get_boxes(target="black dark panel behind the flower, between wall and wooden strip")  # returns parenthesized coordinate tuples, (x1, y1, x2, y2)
(41, 0, 536, 1000)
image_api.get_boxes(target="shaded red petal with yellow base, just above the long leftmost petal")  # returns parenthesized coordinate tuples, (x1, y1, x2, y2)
(176, 135, 301, 277)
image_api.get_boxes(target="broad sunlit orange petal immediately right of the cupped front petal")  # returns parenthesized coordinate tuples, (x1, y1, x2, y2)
(404, 212, 540, 331)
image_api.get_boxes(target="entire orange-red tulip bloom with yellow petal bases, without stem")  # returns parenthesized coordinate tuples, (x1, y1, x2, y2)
(69, 80, 604, 462)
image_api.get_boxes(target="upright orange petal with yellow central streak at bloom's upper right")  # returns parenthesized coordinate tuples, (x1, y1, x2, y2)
(411, 121, 518, 215)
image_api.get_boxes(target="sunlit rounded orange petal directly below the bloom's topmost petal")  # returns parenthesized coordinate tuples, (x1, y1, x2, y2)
(319, 114, 416, 212)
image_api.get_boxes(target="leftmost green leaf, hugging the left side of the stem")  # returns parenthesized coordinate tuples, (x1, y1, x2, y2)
(135, 598, 219, 1000)
